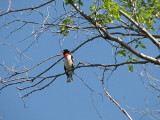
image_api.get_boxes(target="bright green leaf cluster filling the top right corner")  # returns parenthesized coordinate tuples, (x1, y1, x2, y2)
(121, 0, 160, 31)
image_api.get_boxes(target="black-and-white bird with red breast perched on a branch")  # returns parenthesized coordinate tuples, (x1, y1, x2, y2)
(62, 49, 74, 82)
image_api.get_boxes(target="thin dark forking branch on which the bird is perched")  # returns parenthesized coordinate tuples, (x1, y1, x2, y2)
(0, 58, 148, 90)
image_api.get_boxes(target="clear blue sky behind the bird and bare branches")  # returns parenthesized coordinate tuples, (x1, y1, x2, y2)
(0, 0, 160, 120)
